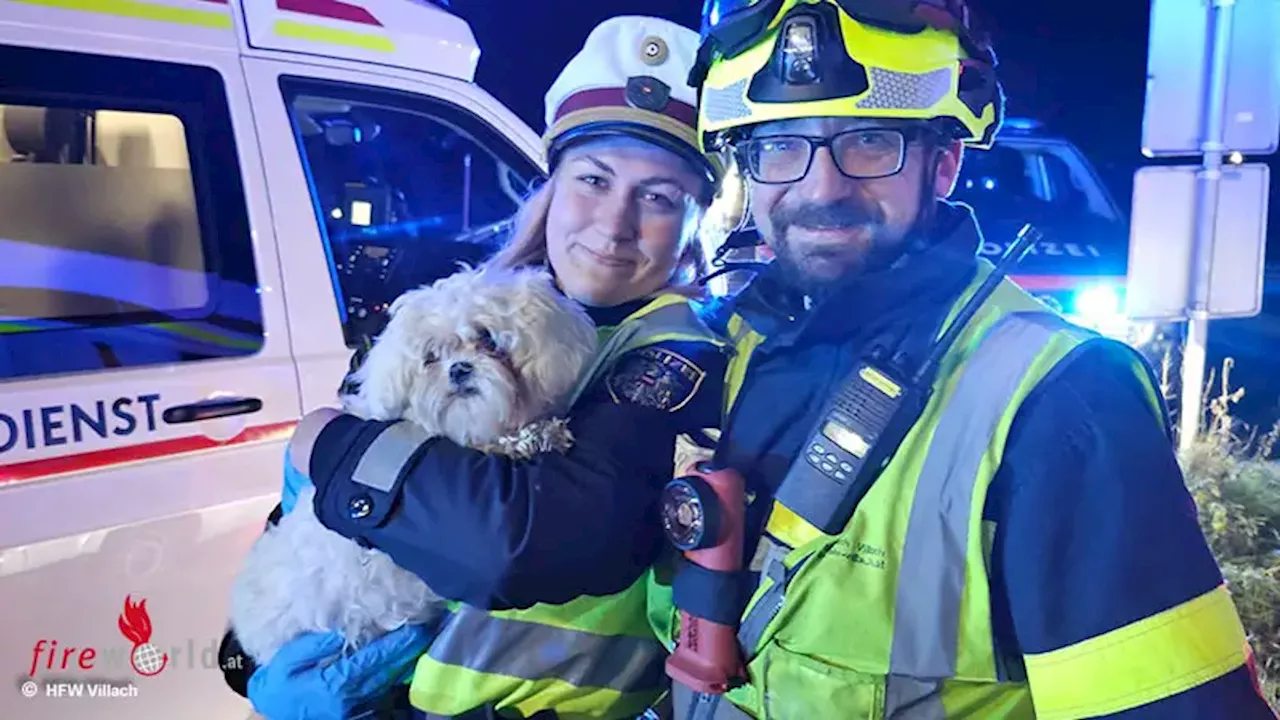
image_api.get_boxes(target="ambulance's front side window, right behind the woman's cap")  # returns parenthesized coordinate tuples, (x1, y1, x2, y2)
(282, 78, 539, 346)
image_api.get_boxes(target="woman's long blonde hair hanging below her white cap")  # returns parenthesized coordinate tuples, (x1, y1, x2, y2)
(486, 162, 708, 297)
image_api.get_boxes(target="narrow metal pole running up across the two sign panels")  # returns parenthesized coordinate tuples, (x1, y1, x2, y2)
(1178, 0, 1235, 451)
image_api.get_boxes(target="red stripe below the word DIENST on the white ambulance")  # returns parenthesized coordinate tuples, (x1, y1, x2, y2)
(0, 420, 297, 486)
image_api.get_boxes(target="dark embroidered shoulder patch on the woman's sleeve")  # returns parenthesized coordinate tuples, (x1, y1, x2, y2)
(605, 346, 707, 413)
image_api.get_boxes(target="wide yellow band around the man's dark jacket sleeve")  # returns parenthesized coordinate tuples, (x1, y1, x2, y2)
(1027, 585, 1248, 720)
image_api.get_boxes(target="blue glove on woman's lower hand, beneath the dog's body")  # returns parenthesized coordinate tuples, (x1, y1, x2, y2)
(248, 625, 431, 720)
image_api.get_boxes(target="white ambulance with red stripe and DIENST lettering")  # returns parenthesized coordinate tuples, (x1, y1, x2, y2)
(0, 0, 544, 720)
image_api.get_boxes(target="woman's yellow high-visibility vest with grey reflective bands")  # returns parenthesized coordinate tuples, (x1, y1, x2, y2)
(410, 295, 727, 720)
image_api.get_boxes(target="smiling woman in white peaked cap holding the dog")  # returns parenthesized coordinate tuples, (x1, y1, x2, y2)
(228, 17, 726, 719)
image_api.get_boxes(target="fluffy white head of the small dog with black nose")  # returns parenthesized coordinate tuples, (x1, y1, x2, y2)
(349, 263, 596, 447)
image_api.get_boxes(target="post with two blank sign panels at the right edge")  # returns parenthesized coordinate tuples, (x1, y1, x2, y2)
(1129, 0, 1280, 450)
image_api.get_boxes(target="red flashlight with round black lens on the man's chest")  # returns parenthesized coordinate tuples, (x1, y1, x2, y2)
(662, 462, 746, 694)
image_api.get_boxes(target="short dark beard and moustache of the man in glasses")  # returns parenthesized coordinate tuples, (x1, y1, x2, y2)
(769, 200, 901, 296)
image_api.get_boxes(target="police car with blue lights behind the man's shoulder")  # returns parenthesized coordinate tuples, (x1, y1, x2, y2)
(952, 118, 1164, 348)
